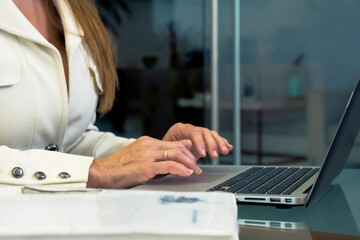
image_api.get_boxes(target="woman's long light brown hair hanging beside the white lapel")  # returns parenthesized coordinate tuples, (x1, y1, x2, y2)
(50, 0, 118, 115)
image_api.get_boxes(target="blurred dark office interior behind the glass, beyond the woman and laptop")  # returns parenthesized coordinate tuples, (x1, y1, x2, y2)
(97, 0, 360, 166)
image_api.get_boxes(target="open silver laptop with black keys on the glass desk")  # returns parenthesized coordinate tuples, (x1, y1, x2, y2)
(133, 81, 360, 206)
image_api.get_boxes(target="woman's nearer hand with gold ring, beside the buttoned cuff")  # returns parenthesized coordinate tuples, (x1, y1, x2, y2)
(87, 137, 201, 188)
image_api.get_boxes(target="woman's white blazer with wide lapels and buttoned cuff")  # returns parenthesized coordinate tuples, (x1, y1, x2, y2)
(0, 0, 134, 185)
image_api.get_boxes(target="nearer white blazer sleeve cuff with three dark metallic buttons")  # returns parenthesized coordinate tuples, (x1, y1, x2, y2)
(0, 146, 94, 186)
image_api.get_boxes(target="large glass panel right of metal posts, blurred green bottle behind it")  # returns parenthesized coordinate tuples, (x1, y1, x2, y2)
(240, 0, 360, 164)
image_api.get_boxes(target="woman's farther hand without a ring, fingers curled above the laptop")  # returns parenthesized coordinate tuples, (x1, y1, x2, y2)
(163, 123, 233, 159)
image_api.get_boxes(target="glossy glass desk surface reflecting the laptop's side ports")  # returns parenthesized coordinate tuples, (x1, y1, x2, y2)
(238, 169, 360, 240)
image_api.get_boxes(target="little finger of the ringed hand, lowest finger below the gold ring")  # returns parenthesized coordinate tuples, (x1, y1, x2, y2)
(152, 161, 194, 177)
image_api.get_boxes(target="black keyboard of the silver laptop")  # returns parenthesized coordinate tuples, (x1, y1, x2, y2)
(208, 167, 319, 195)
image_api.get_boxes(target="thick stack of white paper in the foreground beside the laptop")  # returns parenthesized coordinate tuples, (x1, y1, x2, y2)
(0, 190, 238, 239)
